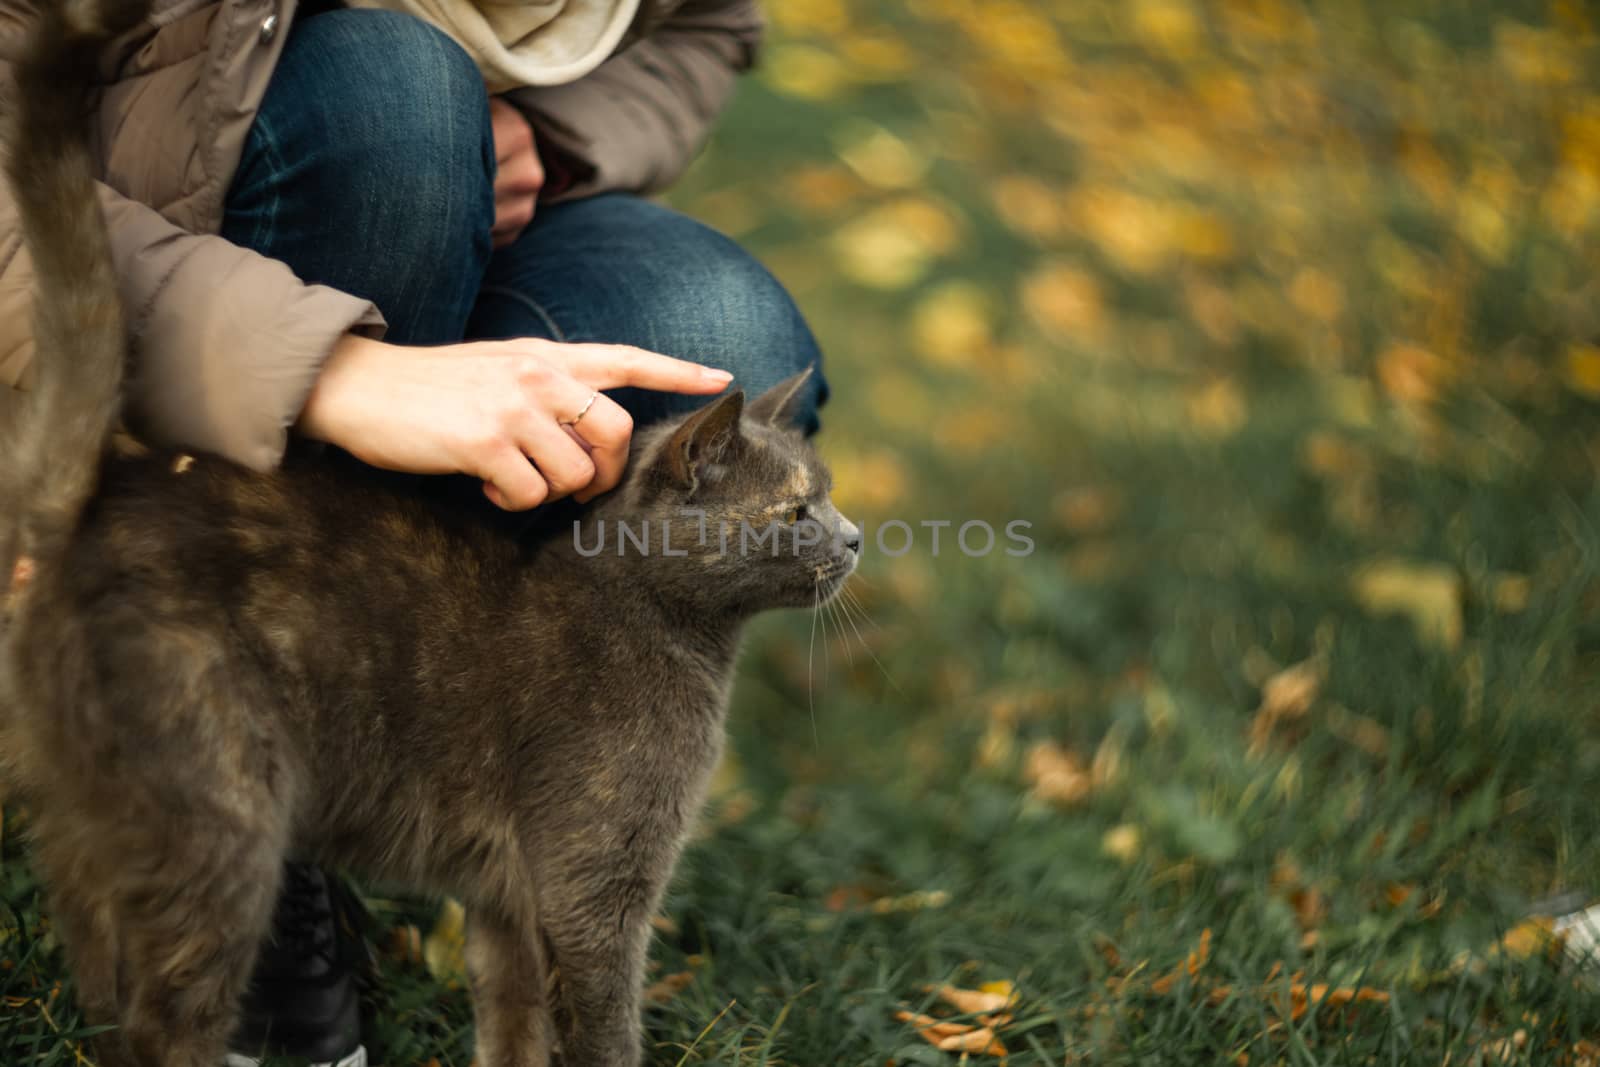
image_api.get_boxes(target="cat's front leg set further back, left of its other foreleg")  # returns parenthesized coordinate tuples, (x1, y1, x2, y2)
(466, 907, 554, 1067)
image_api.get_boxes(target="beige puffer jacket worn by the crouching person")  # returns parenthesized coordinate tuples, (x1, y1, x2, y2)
(0, 0, 762, 469)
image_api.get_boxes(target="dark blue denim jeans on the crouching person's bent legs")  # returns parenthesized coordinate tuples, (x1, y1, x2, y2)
(222, 10, 827, 432)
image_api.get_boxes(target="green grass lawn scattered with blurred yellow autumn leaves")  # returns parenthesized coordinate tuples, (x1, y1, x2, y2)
(0, 0, 1600, 1067)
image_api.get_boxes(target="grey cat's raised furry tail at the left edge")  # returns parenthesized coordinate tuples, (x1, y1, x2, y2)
(0, 0, 149, 572)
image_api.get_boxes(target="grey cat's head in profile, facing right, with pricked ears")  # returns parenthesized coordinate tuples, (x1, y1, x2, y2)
(592, 371, 861, 613)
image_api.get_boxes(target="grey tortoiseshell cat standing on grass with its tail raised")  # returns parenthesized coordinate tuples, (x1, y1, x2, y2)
(0, 0, 856, 1067)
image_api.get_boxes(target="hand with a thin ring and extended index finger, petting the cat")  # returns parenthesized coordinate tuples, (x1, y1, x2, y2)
(299, 334, 733, 510)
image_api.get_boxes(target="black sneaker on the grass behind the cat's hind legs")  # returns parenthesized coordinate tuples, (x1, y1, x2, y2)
(227, 864, 366, 1067)
